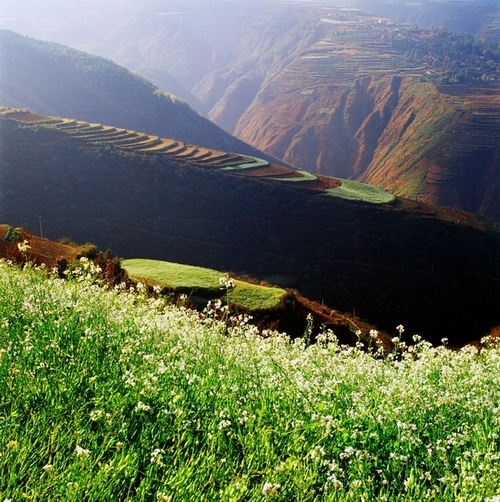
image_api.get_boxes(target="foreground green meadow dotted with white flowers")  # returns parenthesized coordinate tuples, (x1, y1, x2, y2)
(0, 261, 500, 502)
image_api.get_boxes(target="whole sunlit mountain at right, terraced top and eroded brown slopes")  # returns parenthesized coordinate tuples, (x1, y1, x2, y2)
(224, 9, 500, 219)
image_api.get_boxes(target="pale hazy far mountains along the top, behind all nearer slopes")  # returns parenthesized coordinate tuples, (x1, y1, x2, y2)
(0, 0, 500, 111)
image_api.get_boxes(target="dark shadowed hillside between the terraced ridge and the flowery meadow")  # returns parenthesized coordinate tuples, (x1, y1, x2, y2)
(0, 109, 500, 345)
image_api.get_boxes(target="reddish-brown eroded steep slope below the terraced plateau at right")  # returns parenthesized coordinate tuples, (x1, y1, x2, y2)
(236, 76, 500, 219)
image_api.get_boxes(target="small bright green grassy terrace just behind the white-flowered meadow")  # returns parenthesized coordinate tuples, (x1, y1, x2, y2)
(122, 259, 287, 310)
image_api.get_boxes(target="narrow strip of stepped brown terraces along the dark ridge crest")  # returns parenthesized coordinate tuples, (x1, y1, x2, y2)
(0, 107, 396, 202)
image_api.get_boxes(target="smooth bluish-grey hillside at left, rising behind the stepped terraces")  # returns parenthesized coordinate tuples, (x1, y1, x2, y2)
(0, 30, 278, 163)
